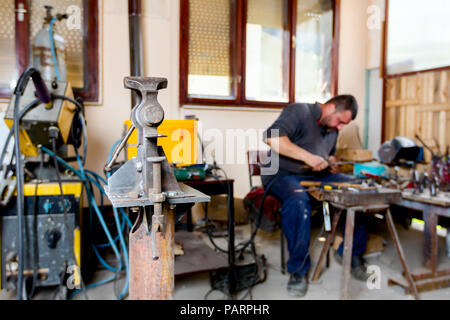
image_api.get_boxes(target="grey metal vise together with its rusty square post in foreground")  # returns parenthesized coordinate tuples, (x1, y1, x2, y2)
(105, 77, 209, 300)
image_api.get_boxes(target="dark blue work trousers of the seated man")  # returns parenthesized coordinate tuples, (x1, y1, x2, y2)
(269, 173, 367, 275)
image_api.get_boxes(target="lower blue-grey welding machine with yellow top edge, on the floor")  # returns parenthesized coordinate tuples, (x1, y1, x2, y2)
(0, 182, 85, 289)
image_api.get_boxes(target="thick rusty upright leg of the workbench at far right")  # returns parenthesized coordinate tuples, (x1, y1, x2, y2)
(423, 209, 438, 275)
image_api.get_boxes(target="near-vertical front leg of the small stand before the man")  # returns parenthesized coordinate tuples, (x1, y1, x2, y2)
(341, 208, 355, 300)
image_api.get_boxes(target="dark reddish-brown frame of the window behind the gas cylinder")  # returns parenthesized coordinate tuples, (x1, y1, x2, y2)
(0, 0, 100, 103)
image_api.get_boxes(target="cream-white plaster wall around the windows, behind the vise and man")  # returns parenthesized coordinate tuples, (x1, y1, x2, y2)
(0, 0, 367, 198)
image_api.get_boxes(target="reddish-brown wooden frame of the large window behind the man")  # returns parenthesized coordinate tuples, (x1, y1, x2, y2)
(179, 0, 340, 108)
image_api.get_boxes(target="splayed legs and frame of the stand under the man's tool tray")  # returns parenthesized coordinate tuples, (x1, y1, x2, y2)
(312, 202, 419, 300)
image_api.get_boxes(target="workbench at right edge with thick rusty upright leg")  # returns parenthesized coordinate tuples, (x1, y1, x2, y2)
(388, 189, 450, 294)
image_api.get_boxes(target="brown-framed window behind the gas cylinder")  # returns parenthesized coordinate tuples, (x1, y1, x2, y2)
(0, 0, 99, 101)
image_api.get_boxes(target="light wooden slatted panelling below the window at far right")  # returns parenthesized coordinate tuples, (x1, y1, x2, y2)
(384, 70, 450, 161)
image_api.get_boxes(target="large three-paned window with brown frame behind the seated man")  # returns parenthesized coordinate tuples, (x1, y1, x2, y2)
(180, 0, 339, 107)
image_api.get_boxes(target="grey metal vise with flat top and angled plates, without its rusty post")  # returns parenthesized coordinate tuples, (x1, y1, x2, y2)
(106, 77, 183, 208)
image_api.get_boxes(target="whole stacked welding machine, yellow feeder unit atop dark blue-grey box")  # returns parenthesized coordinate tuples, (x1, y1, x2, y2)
(0, 68, 91, 299)
